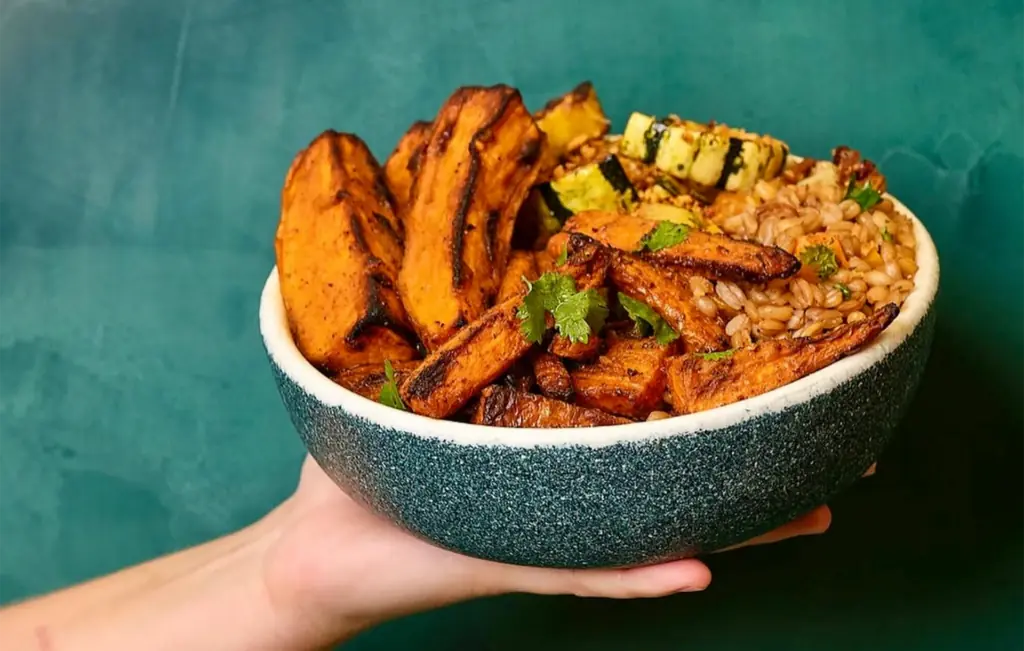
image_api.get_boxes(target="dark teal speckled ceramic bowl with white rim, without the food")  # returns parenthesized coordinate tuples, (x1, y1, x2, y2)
(260, 194, 939, 567)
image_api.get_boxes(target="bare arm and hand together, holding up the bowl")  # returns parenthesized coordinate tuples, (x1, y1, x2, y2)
(0, 459, 830, 651)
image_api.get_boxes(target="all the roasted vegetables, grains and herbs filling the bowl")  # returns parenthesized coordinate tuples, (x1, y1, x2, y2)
(275, 83, 916, 428)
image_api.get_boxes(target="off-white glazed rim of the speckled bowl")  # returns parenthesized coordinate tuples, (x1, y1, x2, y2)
(259, 188, 939, 448)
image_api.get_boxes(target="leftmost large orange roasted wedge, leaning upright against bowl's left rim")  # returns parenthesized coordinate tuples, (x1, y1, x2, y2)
(274, 131, 416, 372)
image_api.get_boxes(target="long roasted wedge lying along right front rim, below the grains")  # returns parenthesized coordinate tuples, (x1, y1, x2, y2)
(668, 304, 899, 414)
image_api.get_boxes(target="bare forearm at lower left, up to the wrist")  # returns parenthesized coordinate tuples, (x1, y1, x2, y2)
(0, 503, 344, 651)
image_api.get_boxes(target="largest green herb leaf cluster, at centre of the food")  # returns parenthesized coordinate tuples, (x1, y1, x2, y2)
(516, 271, 608, 343)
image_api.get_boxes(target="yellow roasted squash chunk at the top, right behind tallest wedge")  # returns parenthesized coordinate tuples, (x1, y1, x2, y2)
(534, 82, 611, 177)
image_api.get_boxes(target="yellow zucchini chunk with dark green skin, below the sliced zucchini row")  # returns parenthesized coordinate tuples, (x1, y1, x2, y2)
(537, 155, 637, 224)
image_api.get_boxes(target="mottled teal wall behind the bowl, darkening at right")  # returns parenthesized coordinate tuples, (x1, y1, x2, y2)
(0, 0, 1024, 651)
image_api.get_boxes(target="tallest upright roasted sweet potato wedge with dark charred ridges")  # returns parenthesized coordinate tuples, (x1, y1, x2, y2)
(398, 86, 544, 350)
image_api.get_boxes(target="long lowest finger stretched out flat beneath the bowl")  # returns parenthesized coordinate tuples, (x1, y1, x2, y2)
(487, 559, 711, 599)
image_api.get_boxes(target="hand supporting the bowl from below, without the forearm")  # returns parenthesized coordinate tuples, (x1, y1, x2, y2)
(265, 458, 830, 644)
